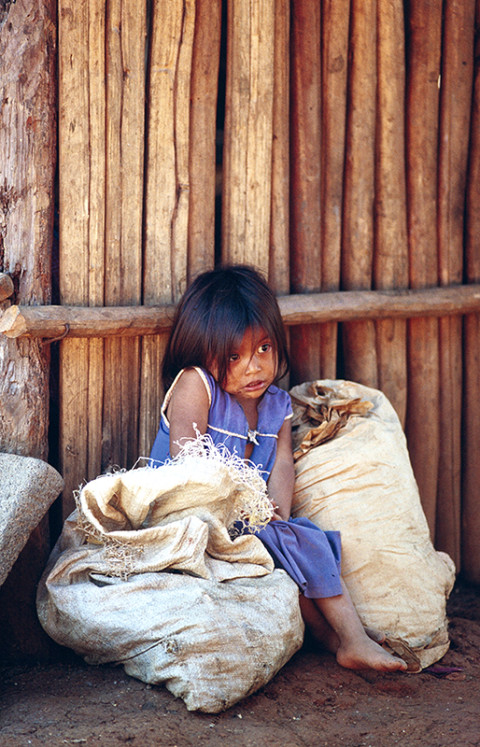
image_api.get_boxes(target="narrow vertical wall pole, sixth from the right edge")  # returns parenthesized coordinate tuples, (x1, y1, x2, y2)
(320, 0, 350, 379)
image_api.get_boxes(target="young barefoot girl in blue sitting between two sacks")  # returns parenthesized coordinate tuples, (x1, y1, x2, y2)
(150, 266, 407, 671)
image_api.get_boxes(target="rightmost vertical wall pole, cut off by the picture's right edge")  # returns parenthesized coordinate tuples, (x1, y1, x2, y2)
(461, 0, 480, 584)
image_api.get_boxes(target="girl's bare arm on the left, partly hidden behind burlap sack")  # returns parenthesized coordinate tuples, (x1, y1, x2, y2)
(166, 368, 209, 457)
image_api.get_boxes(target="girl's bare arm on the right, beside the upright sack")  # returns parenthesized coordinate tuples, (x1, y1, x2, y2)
(268, 420, 295, 521)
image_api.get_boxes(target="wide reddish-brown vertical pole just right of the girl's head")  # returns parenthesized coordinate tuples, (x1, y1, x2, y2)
(290, 0, 322, 384)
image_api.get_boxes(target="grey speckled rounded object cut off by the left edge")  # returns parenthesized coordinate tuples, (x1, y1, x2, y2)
(0, 453, 63, 586)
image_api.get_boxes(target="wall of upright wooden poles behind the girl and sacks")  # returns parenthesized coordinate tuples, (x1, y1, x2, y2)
(0, 0, 480, 636)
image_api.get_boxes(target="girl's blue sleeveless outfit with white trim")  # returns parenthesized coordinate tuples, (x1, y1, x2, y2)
(150, 368, 343, 599)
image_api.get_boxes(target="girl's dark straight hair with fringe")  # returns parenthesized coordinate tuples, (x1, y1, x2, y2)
(162, 265, 289, 390)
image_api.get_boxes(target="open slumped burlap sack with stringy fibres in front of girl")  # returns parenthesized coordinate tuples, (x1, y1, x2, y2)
(37, 444, 303, 713)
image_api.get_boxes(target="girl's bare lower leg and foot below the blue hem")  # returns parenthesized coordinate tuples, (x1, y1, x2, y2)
(300, 579, 407, 672)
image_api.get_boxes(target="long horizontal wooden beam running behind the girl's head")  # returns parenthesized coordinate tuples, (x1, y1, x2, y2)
(0, 284, 480, 340)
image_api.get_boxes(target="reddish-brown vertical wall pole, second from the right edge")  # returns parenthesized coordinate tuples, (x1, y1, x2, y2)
(435, 0, 475, 570)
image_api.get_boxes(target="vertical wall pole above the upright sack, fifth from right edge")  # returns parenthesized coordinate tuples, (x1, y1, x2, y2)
(342, 0, 378, 387)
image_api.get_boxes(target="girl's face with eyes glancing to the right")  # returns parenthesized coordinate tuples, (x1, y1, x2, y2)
(212, 327, 277, 402)
